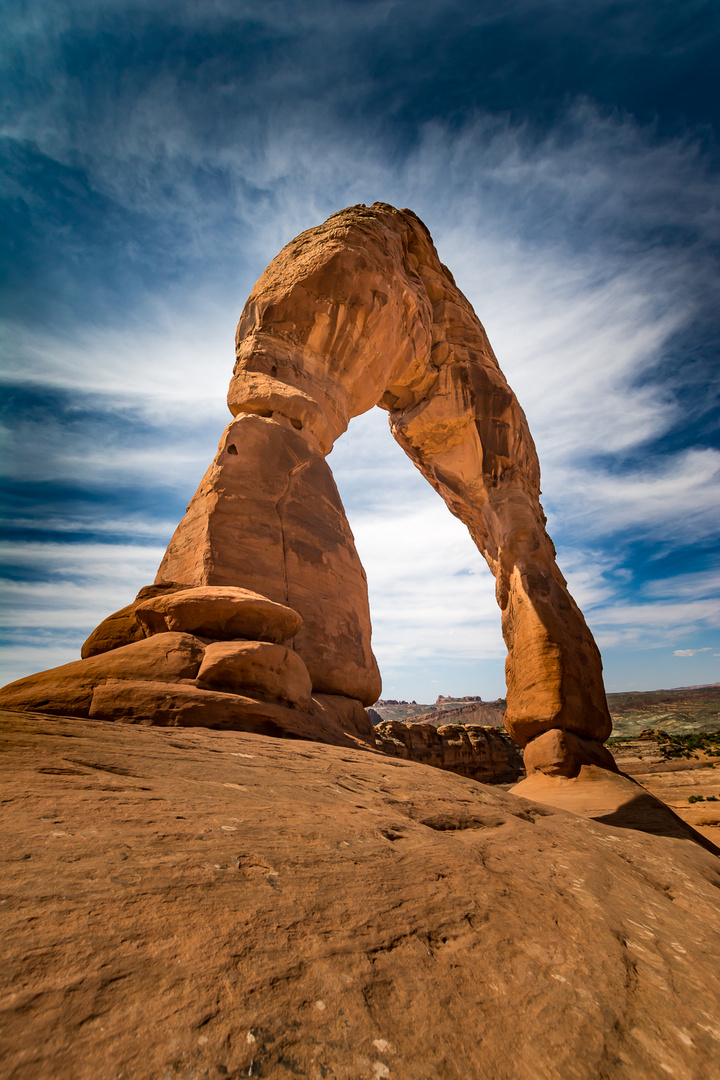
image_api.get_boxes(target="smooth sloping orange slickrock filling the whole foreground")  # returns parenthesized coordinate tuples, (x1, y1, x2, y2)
(0, 713, 720, 1080)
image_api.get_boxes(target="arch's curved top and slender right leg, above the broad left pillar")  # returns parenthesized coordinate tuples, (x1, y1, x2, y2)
(228, 203, 611, 745)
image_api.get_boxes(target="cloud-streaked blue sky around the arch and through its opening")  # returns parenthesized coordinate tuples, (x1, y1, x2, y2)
(0, 0, 720, 701)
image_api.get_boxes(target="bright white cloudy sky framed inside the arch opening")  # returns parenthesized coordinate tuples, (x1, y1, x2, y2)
(327, 408, 507, 703)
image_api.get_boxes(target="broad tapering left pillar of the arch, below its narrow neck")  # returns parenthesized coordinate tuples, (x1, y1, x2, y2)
(157, 415, 381, 705)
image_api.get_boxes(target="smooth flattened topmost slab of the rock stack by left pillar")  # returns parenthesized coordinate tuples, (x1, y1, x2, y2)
(135, 585, 302, 643)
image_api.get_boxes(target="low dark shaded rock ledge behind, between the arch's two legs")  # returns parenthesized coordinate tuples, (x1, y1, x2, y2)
(375, 720, 524, 784)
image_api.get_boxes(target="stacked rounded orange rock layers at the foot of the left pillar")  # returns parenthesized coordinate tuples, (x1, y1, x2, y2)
(1, 586, 373, 746)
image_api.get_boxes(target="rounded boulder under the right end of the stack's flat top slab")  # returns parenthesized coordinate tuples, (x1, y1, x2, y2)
(196, 642, 312, 708)
